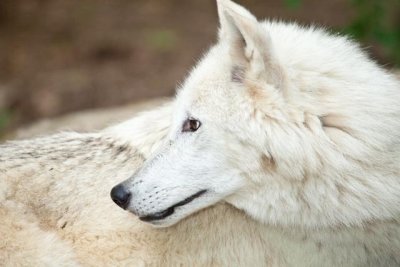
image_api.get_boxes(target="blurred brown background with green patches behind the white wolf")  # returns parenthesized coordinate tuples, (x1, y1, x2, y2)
(0, 0, 400, 137)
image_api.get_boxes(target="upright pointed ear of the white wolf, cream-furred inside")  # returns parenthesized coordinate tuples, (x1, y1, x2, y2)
(217, 0, 284, 87)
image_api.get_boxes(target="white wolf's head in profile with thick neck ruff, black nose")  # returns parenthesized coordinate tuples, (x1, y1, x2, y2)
(111, 0, 400, 227)
